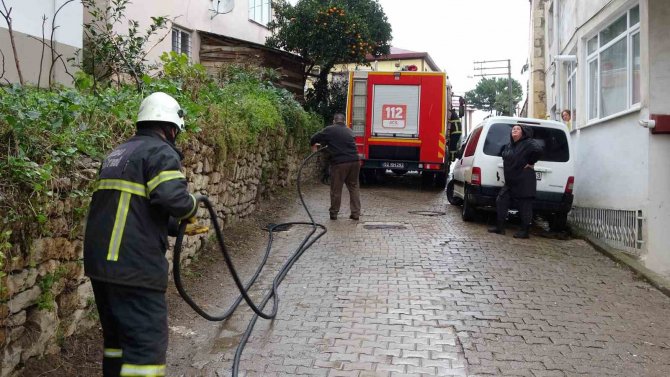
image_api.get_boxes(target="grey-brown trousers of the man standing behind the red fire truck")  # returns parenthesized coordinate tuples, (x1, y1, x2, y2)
(330, 161, 361, 217)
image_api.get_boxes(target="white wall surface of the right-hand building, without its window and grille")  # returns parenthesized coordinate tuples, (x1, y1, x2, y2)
(531, 0, 670, 276)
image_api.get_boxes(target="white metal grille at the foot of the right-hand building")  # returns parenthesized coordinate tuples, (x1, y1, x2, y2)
(569, 207, 644, 256)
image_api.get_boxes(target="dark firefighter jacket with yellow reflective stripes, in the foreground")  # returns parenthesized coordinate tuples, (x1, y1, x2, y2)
(84, 129, 197, 291)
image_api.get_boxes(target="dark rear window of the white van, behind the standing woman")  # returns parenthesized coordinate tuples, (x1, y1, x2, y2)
(484, 123, 570, 162)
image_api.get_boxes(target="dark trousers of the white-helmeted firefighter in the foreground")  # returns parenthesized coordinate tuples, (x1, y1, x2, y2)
(91, 280, 168, 377)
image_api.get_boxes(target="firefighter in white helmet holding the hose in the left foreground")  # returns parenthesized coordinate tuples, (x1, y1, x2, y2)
(84, 92, 207, 376)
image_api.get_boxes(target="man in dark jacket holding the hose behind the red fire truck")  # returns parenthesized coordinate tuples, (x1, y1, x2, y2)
(310, 113, 361, 220)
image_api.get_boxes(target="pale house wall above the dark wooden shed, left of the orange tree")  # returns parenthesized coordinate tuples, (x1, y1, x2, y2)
(116, 0, 270, 62)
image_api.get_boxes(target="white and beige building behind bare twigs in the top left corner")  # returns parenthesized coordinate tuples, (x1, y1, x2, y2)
(0, 0, 83, 86)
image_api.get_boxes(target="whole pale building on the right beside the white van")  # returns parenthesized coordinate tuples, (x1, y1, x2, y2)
(528, 0, 670, 276)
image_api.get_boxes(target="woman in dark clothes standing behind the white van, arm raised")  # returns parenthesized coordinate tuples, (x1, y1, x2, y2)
(489, 125, 542, 238)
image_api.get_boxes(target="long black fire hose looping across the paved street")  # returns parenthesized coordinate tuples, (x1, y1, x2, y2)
(172, 147, 327, 376)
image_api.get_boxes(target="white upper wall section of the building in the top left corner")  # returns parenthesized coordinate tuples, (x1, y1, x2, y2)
(0, 0, 84, 47)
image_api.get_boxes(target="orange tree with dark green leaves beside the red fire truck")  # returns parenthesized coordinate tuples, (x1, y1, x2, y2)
(267, 0, 391, 120)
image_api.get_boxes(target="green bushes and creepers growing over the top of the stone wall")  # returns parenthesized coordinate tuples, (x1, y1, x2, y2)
(0, 53, 323, 282)
